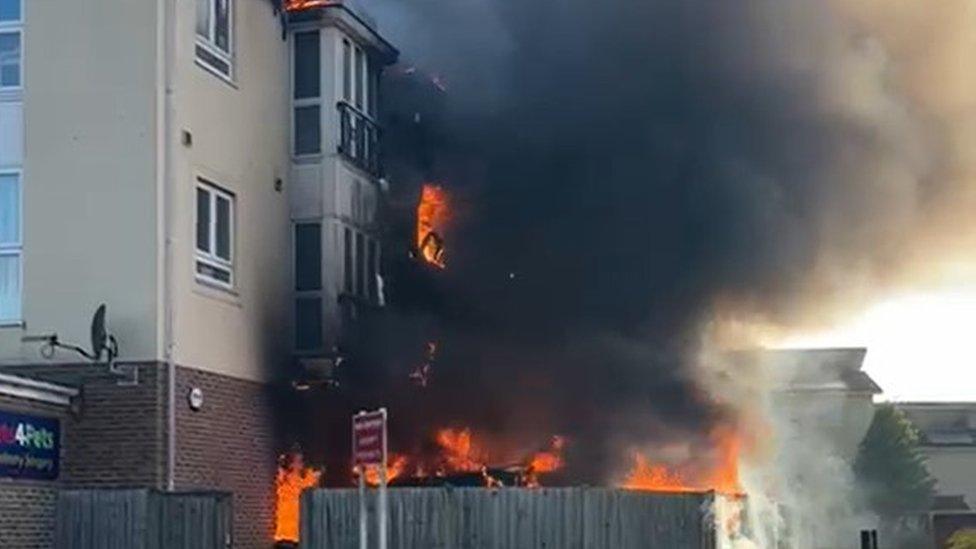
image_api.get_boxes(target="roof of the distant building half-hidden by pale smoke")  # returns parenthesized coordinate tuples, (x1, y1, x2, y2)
(733, 347, 882, 395)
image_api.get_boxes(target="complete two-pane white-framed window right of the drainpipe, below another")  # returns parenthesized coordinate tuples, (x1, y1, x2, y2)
(196, 179, 234, 288)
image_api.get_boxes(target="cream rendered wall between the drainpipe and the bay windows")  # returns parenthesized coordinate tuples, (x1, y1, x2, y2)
(170, 0, 292, 381)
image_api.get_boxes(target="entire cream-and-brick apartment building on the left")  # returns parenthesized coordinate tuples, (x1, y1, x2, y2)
(0, 0, 397, 547)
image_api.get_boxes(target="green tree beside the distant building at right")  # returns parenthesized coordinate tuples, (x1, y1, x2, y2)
(854, 404, 935, 520)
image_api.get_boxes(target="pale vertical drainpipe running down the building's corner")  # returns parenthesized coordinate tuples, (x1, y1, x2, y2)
(156, 0, 176, 491)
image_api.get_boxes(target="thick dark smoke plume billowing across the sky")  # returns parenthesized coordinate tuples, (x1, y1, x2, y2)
(300, 0, 976, 488)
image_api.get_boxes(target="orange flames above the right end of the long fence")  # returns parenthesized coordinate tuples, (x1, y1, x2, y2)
(622, 428, 742, 494)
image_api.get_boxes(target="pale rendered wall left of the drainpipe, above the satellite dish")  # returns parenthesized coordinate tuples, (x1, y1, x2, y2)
(0, 0, 157, 362)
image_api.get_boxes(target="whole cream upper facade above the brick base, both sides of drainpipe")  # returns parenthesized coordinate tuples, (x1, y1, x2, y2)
(0, 0, 393, 381)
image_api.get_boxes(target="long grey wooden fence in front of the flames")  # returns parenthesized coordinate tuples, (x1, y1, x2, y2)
(301, 488, 724, 549)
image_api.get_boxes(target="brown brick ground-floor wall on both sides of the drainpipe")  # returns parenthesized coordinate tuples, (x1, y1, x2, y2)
(0, 363, 277, 549)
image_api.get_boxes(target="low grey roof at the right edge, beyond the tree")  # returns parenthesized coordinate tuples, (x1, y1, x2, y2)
(894, 402, 976, 448)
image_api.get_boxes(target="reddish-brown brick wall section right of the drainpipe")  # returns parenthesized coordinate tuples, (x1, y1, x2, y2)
(176, 367, 276, 549)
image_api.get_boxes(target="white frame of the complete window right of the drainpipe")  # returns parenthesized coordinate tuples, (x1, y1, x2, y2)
(193, 180, 237, 290)
